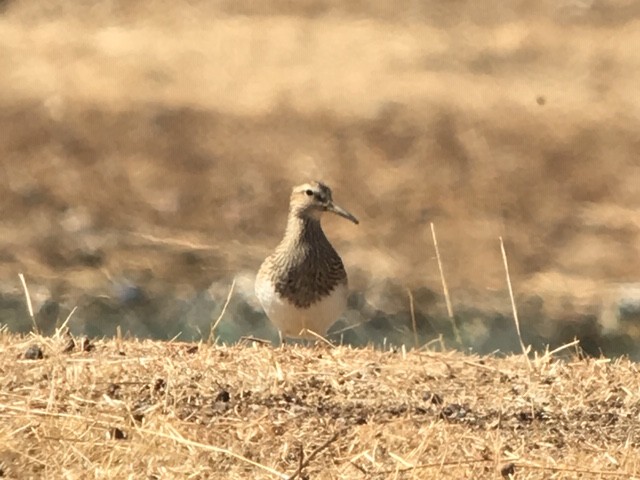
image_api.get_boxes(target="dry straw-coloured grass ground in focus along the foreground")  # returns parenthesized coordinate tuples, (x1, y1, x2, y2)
(0, 332, 640, 479)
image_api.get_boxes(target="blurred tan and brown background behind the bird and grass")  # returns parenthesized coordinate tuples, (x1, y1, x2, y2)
(0, 0, 640, 358)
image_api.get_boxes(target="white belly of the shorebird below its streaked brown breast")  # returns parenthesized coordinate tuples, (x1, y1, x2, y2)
(256, 276, 349, 338)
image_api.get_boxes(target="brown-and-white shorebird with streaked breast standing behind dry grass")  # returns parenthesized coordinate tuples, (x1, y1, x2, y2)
(255, 182, 358, 338)
